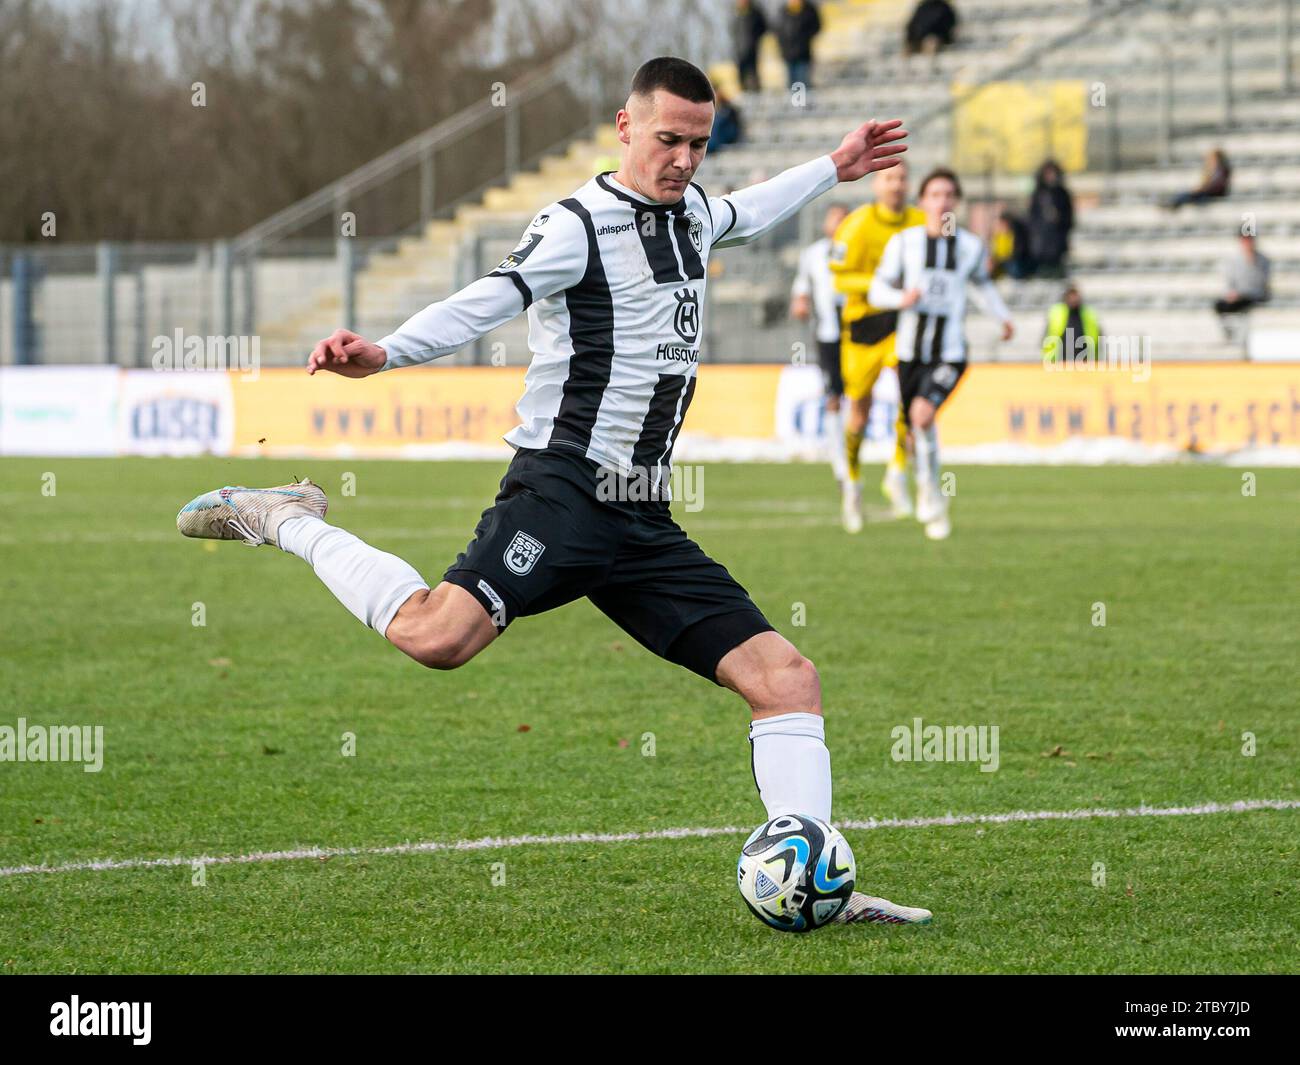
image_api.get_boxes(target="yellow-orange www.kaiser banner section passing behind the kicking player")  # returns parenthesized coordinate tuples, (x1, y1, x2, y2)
(231, 365, 781, 455)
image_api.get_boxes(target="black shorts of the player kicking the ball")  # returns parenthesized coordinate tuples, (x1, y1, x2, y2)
(443, 447, 772, 683)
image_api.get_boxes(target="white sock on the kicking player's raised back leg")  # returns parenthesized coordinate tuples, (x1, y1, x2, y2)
(276, 515, 429, 636)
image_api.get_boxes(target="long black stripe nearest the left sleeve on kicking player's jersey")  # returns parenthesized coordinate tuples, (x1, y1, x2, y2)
(551, 198, 614, 453)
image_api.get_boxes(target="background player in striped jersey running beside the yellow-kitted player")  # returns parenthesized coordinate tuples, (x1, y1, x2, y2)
(868, 169, 1013, 540)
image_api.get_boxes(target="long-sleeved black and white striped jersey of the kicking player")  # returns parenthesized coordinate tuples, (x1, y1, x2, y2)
(378, 156, 837, 481)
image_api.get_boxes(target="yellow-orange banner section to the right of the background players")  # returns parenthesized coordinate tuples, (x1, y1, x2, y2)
(939, 363, 1300, 451)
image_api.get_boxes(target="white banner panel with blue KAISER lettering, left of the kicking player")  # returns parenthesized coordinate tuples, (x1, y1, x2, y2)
(118, 369, 234, 455)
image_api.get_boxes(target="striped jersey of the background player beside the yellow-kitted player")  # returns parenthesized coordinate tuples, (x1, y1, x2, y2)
(867, 225, 1011, 363)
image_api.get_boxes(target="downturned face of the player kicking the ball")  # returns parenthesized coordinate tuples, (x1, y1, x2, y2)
(619, 88, 714, 203)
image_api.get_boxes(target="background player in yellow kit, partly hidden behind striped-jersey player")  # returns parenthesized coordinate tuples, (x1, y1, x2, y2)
(829, 164, 926, 532)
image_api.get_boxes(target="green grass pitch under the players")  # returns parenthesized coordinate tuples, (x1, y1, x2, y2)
(0, 459, 1300, 973)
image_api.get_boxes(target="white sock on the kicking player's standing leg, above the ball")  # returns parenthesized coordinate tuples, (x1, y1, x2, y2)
(749, 714, 831, 821)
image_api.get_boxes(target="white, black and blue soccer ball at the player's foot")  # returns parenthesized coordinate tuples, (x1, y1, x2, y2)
(736, 814, 857, 932)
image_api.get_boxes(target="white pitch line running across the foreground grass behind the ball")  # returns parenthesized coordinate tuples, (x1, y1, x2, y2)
(0, 798, 1300, 876)
